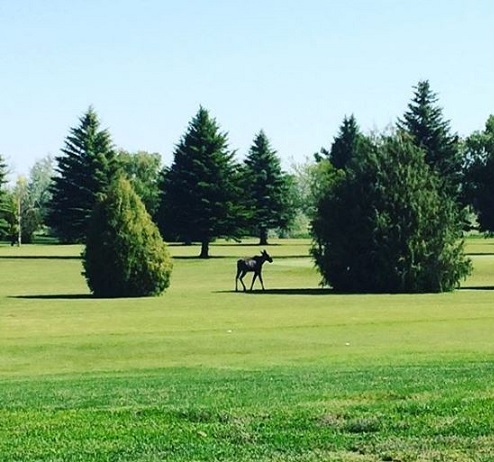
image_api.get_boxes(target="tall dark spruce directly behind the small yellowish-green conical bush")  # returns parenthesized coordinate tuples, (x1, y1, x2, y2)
(47, 107, 117, 243)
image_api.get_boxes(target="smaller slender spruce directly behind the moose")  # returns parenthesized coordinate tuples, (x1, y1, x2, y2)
(243, 130, 295, 245)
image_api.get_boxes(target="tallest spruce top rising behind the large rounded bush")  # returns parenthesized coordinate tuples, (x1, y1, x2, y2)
(397, 80, 462, 195)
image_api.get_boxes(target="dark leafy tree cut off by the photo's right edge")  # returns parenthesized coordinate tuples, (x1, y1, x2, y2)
(464, 115, 494, 233)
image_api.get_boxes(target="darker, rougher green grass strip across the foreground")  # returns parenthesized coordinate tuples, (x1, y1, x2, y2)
(0, 362, 494, 461)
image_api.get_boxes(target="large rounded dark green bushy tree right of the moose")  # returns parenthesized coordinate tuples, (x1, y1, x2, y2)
(312, 134, 471, 292)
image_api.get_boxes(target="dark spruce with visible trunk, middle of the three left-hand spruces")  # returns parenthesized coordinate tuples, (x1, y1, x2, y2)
(157, 107, 240, 258)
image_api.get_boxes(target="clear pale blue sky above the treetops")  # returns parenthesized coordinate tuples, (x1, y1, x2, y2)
(0, 0, 494, 178)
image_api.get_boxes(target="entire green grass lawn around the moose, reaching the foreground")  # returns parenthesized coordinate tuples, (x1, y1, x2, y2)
(0, 239, 494, 462)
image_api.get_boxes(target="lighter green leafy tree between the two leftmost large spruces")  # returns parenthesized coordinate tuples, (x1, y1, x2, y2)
(117, 150, 161, 216)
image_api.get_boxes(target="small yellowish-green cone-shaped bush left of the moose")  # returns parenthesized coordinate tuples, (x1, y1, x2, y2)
(83, 178, 172, 297)
